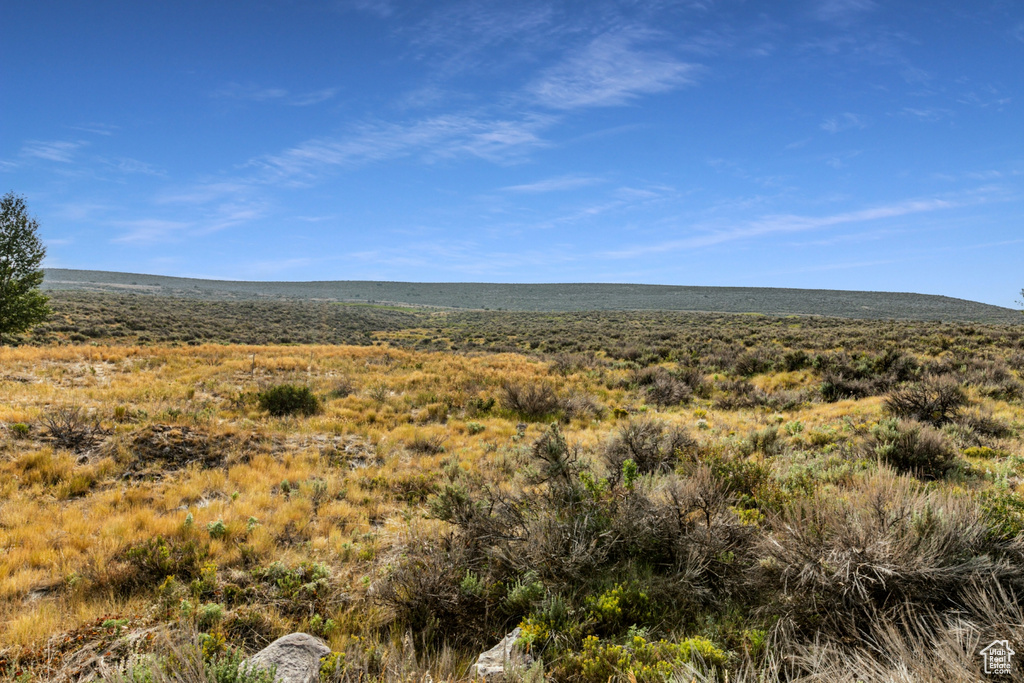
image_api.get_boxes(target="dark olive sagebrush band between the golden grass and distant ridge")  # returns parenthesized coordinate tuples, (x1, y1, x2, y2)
(14, 291, 1024, 358)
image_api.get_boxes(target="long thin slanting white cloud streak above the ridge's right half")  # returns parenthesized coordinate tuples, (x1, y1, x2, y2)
(605, 199, 961, 258)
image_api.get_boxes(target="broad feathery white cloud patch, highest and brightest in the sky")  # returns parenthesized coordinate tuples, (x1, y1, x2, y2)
(526, 33, 696, 110)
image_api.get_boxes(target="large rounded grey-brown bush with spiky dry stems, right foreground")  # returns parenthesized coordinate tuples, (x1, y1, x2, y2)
(755, 470, 1007, 643)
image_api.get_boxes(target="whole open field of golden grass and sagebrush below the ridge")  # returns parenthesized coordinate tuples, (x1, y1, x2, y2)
(0, 305, 1024, 683)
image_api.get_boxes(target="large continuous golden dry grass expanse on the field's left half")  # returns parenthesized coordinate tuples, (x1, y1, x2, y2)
(0, 346, 598, 645)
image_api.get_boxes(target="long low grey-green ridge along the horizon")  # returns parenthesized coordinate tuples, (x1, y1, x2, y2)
(43, 268, 1024, 325)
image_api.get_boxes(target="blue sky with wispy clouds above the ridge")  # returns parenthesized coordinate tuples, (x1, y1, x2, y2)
(0, 0, 1024, 306)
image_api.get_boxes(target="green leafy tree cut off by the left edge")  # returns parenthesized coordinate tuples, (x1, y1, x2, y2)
(0, 193, 50, 343)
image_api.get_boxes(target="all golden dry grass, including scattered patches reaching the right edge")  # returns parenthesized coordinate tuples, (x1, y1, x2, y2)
(0, 345, 1024, 679)
